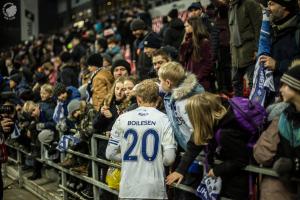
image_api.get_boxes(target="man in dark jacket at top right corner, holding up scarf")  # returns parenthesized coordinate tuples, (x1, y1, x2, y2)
(260, 0, 300, 103)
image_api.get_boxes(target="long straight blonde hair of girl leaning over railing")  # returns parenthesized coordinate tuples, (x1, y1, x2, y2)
(185, 92, 227, 145)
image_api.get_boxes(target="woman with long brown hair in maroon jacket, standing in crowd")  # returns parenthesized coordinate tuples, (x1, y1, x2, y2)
(179, 17, 213, 91)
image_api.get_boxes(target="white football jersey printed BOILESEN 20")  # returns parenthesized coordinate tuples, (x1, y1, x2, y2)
(109, 107, 176, 199)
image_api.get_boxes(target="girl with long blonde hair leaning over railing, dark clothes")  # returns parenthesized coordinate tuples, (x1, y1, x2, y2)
(167, 92, 250, 199)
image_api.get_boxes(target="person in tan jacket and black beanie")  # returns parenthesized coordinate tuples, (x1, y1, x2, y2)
(87, 54, 114, 111)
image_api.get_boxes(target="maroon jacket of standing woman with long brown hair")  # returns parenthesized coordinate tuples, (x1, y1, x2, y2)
(179, 35, 213, 90)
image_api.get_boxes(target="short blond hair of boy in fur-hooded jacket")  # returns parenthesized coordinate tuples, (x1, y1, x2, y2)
(158, 61, 185, 86)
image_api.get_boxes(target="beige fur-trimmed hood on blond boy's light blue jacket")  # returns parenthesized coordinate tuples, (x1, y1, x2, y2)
(171, 72, 204, 101)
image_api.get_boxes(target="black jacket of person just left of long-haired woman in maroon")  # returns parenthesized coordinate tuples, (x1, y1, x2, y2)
(163, 18, 184, 49)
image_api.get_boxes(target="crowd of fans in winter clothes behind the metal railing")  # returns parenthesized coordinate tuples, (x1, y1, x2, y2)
(0, 0, 300, 200)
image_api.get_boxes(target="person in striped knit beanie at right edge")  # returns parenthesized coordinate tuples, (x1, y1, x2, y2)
(273, 60, 300, 191)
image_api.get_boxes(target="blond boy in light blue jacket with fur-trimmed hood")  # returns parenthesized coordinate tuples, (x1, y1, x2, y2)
(158, 62, 204, 150)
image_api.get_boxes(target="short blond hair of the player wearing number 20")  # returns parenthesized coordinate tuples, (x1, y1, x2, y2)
(134, 79, 159, 103)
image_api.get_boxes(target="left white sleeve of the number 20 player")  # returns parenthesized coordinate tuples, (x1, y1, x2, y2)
(105, 117, 123, 161)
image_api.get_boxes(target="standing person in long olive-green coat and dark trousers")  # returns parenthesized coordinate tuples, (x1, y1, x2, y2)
(228, 0, 262, 96)
